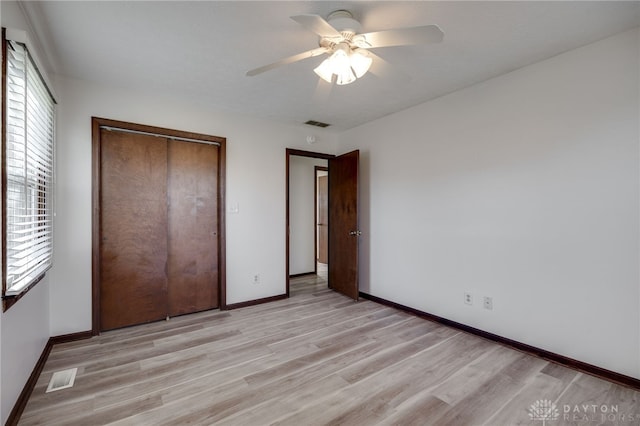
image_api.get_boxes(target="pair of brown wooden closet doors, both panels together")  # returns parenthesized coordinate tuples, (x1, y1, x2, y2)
(100, 129, 219, 330)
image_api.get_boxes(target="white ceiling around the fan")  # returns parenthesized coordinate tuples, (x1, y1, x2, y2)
(23, 1, 640, 130)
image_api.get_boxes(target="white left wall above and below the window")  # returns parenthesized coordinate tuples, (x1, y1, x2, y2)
(0, 1, 49, 424)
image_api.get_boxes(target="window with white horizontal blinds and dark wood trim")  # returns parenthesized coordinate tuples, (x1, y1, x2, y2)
(2, 29, 55, 310)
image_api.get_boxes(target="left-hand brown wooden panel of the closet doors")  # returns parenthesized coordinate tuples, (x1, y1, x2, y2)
(100, 130, 167, 330)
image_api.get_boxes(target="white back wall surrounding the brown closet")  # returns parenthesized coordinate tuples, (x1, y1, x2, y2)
(51, 78, 337, 335)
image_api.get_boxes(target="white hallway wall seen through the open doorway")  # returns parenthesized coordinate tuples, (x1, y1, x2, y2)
(289, 155, 327, 275)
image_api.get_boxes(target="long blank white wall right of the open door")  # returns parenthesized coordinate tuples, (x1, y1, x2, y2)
(340, 31, 640, 378)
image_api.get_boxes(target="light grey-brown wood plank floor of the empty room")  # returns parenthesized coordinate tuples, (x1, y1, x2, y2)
(20, 276, 640, 426)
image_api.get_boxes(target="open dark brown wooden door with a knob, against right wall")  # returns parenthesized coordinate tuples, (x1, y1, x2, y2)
(329, 150, 360, 300)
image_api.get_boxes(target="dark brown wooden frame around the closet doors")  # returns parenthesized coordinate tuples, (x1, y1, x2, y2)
(91, 117, 227, 336)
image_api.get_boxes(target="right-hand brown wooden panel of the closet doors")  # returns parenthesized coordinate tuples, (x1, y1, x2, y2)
(167, 140, 219, 316)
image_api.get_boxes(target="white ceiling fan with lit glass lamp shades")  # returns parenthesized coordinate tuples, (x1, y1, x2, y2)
(247, 10, 444, 85)
